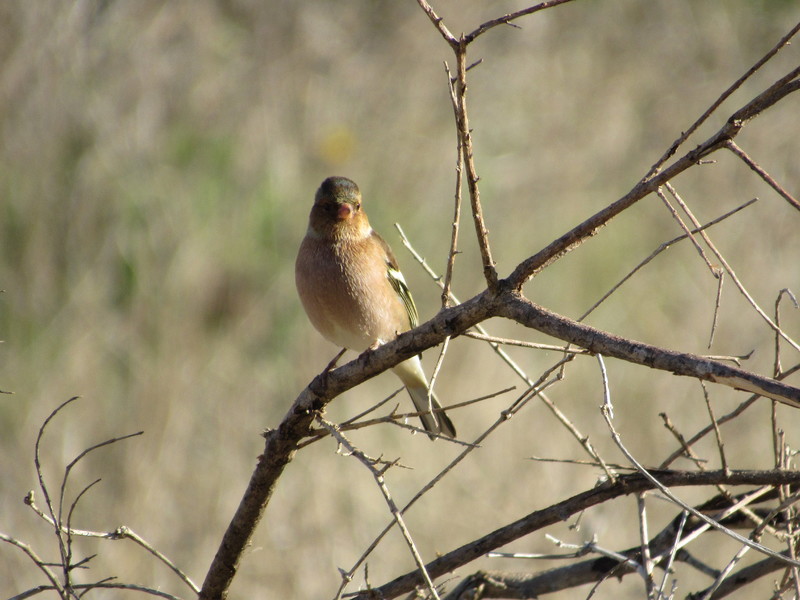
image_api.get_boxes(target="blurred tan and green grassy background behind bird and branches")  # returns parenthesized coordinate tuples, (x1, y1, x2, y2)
(0, 0, 800, 598)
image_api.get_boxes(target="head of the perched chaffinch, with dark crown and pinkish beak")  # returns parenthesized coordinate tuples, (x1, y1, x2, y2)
(308, 177, 372, 239)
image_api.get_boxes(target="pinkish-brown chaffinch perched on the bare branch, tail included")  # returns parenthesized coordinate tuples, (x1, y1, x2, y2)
(295, 177, 456, 439)
